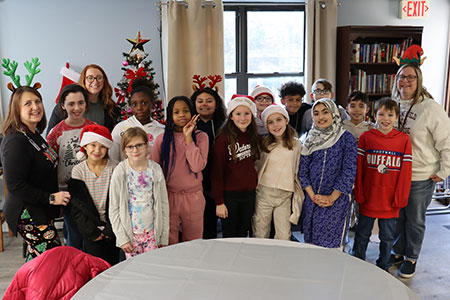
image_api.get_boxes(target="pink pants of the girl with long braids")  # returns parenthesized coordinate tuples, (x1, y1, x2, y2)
(167, 189, 205, 245)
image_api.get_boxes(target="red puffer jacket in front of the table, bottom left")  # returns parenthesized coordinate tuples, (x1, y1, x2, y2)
(3, 246, 111, 300)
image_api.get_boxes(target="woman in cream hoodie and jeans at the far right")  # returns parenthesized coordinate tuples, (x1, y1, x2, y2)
(391, 64, 450, 278)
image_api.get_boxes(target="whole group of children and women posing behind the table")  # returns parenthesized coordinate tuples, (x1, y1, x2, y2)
(0, 64, 450, 277)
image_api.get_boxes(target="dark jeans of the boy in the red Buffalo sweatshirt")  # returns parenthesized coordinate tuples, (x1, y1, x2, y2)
(352, 214, 397, 270)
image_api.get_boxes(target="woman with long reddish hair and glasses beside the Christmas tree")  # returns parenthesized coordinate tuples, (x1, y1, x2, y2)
(47, 64, 120, 134)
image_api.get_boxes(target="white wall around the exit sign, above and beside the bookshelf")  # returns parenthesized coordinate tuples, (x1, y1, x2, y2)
(338, 0, 450, 103)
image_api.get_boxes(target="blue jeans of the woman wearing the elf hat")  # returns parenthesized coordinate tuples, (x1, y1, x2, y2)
(392, 179, 435, 261)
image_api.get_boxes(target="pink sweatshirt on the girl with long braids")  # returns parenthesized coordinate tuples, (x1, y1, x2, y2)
(150, 131, 209, 193)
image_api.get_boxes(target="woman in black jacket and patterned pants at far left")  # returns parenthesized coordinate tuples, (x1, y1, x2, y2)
(0, 86, 70, 261)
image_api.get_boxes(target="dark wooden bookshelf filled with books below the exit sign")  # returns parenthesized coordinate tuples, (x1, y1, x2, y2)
(336, 26, 423, 119)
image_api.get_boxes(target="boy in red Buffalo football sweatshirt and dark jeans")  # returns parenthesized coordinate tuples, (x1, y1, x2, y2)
(352, 98, 412, 270)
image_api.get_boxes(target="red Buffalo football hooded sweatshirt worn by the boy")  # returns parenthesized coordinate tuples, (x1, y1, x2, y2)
(355, 129, 412, 218)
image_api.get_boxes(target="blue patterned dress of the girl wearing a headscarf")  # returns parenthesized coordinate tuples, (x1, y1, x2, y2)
(299, 131, 357, 248)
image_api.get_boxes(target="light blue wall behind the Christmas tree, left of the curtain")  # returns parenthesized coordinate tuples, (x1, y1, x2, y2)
(0, 0, 162, 123)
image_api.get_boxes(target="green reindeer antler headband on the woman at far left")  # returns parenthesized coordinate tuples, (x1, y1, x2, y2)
(2, 57, 41, 92)
